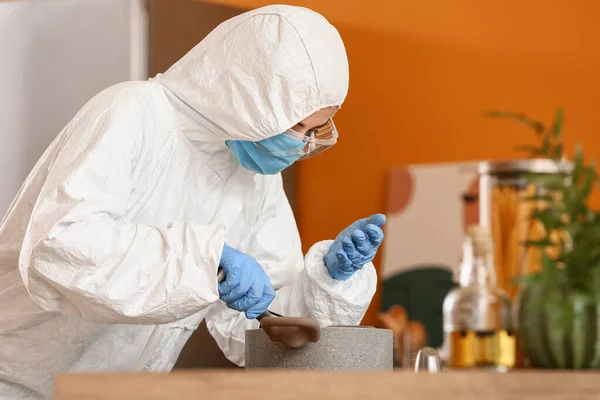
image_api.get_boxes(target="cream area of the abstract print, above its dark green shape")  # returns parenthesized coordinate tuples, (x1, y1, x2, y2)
(381, 162, 477, 279)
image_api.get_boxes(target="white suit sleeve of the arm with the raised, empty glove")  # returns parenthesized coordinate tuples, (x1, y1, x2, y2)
(206, 176, 377, 366)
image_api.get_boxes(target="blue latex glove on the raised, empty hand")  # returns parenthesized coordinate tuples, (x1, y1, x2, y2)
(323, 214, 386, 281)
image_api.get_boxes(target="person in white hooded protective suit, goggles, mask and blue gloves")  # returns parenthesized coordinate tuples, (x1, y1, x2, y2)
(0, 6, 385, 399)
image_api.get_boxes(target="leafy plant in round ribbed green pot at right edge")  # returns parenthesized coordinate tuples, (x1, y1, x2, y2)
(488, 109, 600, 369)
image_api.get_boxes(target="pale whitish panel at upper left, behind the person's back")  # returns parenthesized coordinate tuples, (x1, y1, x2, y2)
(0, 0, 147, 219)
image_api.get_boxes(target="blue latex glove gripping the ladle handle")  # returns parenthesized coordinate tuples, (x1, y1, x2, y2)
(219, 245, 275, 319)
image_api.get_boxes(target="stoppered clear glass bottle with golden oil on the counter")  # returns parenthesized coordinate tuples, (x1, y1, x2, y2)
(443, 225, 516, 371)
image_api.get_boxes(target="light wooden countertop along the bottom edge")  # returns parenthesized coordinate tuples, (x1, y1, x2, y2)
(54, 370, 600, 400)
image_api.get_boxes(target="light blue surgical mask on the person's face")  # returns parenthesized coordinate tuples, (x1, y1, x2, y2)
(225, 133, 305, 175)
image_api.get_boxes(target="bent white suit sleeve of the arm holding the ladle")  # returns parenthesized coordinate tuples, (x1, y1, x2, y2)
(19, 87, 224, 324)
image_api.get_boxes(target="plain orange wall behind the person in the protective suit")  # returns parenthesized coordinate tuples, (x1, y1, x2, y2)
(204, 0, 600, 324)
